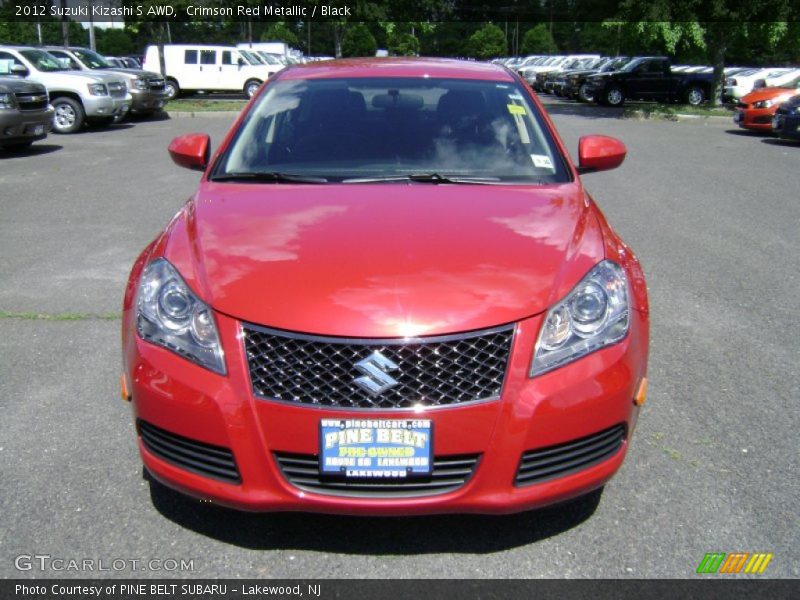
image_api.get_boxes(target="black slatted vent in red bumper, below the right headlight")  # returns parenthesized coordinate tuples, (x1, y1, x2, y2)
(514, 423, 625, 485)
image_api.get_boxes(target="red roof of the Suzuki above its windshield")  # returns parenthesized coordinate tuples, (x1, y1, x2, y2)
(280, 57, 514, 81)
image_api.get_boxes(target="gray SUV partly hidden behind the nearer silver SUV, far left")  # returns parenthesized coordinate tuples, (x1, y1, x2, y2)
(45, 46, 168, 115)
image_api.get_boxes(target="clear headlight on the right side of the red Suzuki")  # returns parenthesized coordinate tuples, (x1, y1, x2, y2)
(530, 260, 630, 377)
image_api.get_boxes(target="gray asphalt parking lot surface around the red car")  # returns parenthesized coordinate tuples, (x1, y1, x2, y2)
(0, 97, 800, 578)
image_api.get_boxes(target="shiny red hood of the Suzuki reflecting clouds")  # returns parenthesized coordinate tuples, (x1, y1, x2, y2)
(160, 183, 604, 337)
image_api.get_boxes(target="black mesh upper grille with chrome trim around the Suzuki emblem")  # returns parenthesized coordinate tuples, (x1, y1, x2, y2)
(243, 324, 514, 409)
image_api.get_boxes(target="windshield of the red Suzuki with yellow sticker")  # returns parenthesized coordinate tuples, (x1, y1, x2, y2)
(212, 78, 570, 185)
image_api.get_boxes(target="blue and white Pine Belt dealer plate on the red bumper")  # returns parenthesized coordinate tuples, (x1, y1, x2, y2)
(319, 419, 433, 481)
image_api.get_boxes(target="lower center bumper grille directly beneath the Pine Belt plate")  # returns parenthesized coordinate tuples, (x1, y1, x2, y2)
(274, 452, 480, 498)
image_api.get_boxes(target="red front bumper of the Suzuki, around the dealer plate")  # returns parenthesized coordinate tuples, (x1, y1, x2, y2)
(123, 310, 648, 515)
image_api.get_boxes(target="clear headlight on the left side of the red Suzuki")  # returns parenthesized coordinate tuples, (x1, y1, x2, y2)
(136, 258, 225, 375)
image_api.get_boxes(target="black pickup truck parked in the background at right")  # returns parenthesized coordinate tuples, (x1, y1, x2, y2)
(586, 56, 714, 106)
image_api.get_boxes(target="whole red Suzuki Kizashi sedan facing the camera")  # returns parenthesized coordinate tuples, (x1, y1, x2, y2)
(121, 59, 649, 515)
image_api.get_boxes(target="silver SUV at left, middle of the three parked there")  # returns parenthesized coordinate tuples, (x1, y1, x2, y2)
(0, 46, 132, 133)
